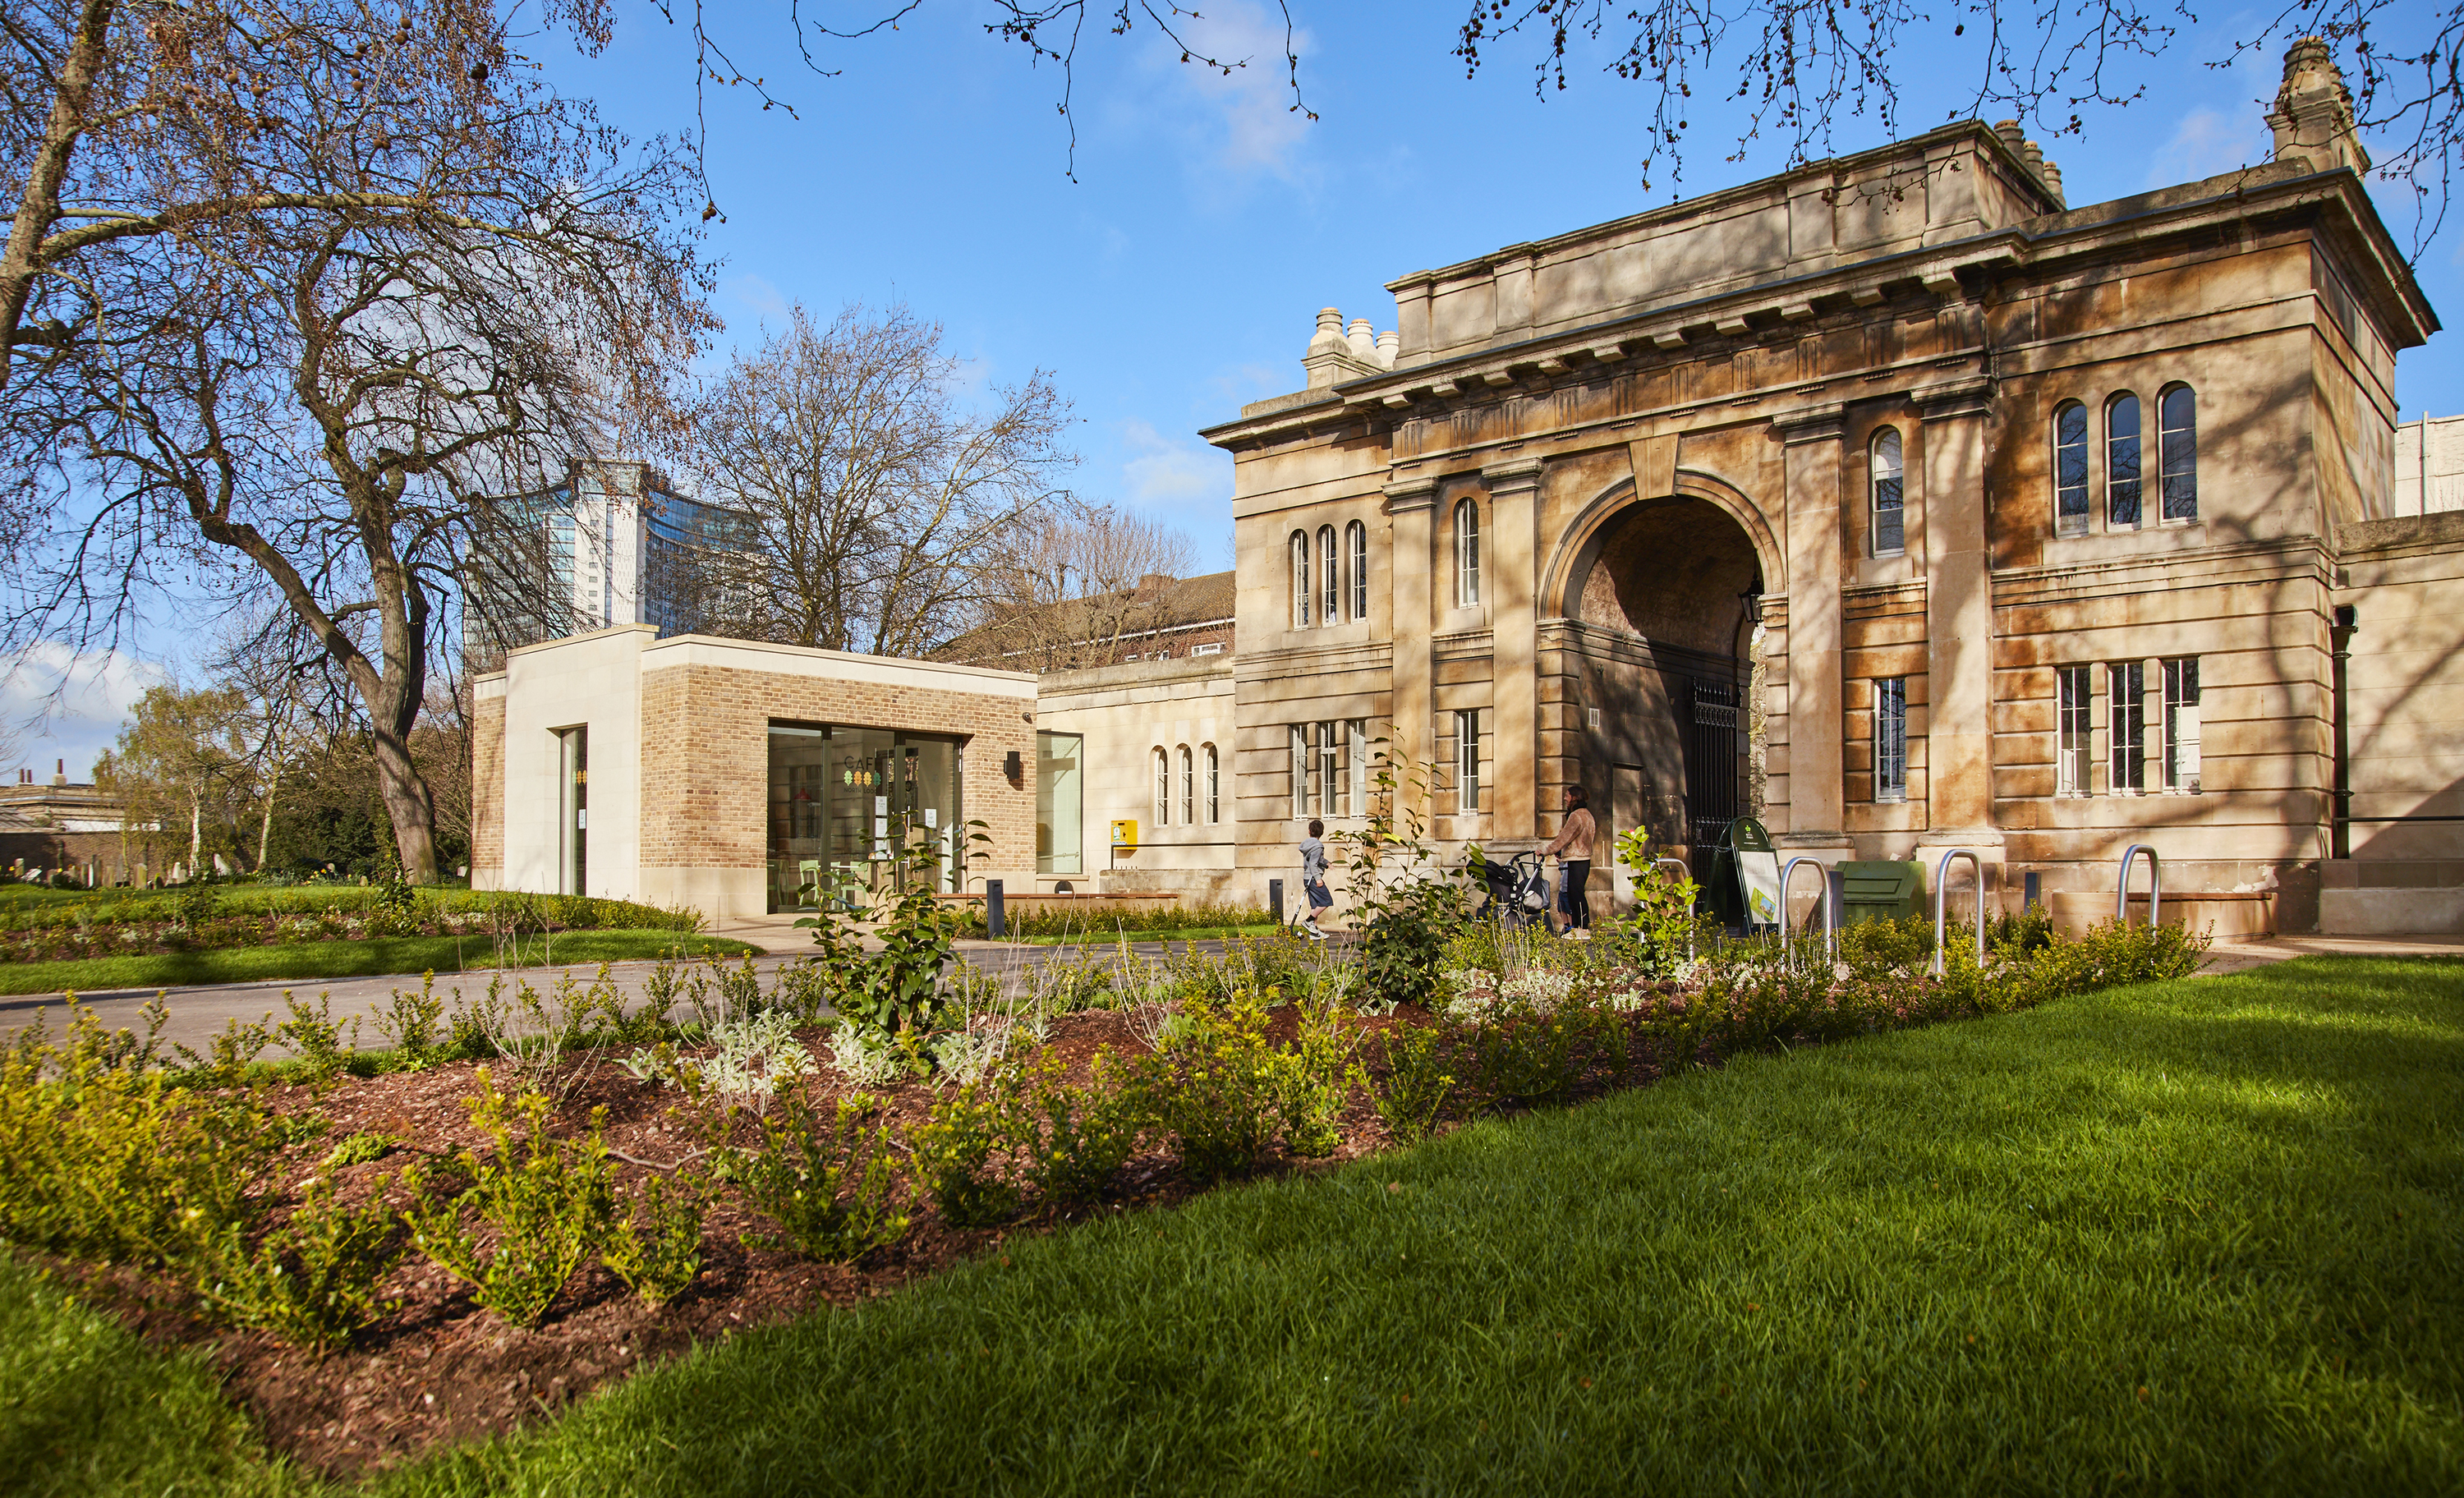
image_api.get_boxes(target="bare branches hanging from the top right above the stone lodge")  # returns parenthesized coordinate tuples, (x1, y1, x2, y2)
(1454, 0, 2464, 254)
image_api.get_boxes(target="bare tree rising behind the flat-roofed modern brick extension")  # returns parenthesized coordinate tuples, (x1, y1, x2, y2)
(683, 308, 1077, 655)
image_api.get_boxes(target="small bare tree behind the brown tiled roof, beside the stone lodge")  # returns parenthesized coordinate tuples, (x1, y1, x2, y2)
(946, 503, 1193, 670)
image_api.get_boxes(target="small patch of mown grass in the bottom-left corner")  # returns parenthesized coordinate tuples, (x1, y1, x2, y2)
(0, 1252, 308, 1498)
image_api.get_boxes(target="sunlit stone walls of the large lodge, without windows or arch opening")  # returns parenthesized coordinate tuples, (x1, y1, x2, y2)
(1207, 108, 2434, 929)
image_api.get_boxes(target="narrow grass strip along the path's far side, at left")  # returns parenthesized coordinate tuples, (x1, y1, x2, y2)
(0, 931, 761, 993)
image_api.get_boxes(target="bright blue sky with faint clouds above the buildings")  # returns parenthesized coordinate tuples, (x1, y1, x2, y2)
(10, 0, 2464, 771)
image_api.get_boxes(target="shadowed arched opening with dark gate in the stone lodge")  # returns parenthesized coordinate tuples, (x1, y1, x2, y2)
(1540, 493, 1767, 894)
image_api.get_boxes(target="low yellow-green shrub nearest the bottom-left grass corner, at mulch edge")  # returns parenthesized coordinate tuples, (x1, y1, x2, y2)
(182, 1173, 404, 1353)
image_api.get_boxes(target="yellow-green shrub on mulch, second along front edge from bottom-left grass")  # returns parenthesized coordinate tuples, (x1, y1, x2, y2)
(402, 1067, 609, 1326)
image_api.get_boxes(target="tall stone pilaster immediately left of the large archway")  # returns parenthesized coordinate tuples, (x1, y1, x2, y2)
(1481, 458, 1540, 840)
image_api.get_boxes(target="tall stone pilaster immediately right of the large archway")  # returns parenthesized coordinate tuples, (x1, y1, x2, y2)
(1772, 402, 1848, 855)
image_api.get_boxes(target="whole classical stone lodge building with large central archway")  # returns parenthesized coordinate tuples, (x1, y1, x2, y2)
(1205, 44, 2464, 931)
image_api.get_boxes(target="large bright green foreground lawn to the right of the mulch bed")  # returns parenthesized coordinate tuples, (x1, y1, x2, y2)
(0, 958, 2464, 1496)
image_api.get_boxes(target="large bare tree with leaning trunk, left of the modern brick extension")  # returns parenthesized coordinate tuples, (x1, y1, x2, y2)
(5, 0, 707, 880)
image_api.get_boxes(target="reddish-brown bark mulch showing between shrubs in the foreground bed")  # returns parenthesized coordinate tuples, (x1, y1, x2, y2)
(43, 1008, 1429, 1478)
